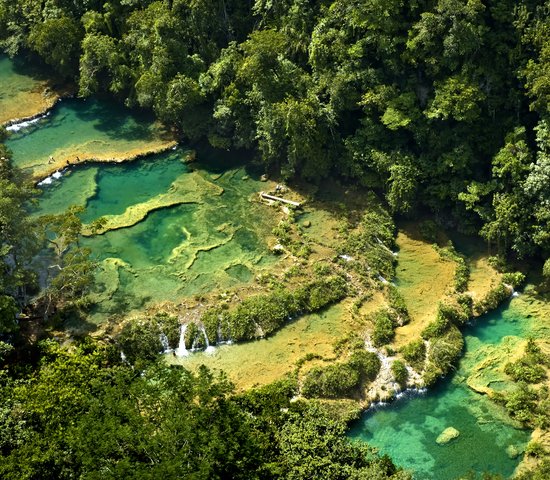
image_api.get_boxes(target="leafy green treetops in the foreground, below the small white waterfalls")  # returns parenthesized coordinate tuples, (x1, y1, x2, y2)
(0, 340, 410, 480)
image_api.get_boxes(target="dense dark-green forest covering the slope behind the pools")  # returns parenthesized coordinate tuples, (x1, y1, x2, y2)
(0, 0, 550, 256)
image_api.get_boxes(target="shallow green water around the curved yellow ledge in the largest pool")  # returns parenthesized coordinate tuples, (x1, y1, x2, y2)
(36, 144, 275, 322)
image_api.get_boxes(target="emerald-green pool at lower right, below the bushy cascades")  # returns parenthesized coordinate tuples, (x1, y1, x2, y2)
(349, 297, 532, 480)
